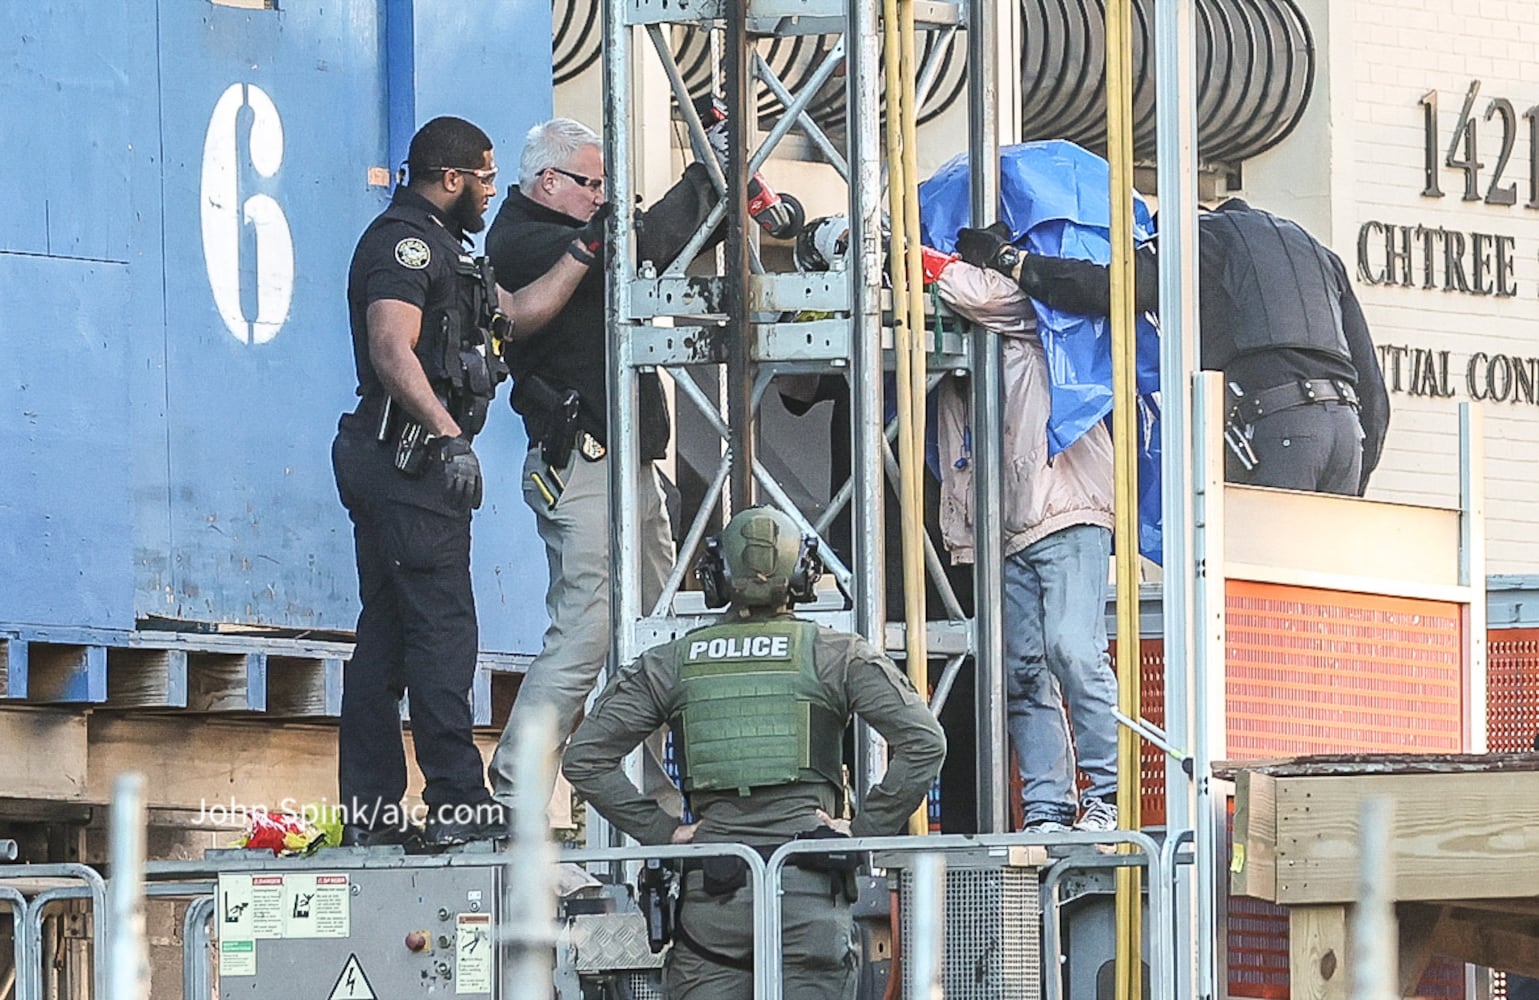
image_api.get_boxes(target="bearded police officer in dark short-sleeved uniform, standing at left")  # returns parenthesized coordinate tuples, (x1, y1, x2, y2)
(332, 117, 597, 846)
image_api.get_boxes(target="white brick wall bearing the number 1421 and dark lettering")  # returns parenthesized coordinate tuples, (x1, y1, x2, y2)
(1245, 0, 1539, 574)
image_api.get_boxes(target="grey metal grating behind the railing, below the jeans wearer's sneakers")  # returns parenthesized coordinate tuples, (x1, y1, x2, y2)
(899, 866, 1042, 1000)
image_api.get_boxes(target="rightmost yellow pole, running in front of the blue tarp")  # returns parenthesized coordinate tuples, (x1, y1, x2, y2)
(1107, 0, 1143, 1000)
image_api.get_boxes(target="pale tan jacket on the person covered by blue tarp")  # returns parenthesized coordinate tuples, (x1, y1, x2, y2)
(936, 260, 1113, 563)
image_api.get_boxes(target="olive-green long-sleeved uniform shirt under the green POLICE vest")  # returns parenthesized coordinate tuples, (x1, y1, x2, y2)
(562, 615, 946, 845)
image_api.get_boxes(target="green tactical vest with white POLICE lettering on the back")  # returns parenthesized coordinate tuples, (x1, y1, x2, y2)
(669, 620, 848, 795)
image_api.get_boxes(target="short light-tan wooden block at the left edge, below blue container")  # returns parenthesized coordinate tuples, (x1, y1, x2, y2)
(0, 706, 86, 802)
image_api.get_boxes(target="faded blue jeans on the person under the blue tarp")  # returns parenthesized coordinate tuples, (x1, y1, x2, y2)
(1003, 525, 1117, 823)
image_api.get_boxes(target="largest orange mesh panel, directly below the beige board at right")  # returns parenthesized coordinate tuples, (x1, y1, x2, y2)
(1225, 580, 1464, 750)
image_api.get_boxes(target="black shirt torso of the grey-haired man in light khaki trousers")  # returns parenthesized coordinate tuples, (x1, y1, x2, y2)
(486, 185, 668, 460)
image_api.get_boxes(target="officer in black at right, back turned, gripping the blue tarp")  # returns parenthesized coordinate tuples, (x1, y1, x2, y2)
(957, 198, 1390, 495)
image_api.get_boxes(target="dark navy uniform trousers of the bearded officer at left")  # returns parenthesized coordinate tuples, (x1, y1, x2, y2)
(332, 431, 489, 825)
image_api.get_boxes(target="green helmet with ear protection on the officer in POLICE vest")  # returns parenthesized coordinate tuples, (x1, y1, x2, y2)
(699, 506, 822, 609)
